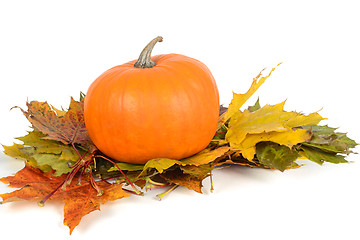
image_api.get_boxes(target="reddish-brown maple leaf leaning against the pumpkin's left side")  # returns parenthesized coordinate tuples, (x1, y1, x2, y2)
(14, 98, 95, 151)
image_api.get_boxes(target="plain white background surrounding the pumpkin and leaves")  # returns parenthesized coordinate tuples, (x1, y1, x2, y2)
(0, 0, 360, 240)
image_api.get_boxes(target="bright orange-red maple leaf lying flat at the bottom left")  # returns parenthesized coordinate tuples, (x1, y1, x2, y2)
(0, 163, 129, 234)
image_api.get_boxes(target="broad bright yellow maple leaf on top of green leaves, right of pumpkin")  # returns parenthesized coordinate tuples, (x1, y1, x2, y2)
(225, 101, 323, 161)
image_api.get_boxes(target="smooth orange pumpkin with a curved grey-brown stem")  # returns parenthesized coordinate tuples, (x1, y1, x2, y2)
(84, 37, 219, 164)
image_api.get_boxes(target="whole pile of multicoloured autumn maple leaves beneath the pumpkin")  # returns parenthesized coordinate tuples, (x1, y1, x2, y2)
(0, 64, 356, 233)
